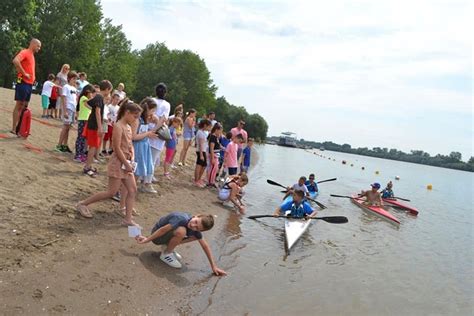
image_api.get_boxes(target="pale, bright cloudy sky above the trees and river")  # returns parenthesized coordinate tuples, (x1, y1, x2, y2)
(101, 0, 474, 160)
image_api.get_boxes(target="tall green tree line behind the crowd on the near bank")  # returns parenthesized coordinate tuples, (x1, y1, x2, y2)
(0, 0, 268, 140)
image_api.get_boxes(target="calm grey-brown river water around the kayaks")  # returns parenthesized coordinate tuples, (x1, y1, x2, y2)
(193, 145, 474, 315)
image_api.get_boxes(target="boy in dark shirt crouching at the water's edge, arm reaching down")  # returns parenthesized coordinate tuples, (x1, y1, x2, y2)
(135, 212, 227, 276)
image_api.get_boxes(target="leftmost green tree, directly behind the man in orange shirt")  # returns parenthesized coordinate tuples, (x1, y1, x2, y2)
(0, 0, 40, 87)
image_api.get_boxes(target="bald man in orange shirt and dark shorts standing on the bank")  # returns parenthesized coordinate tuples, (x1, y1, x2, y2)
(11, 38, 41, 134)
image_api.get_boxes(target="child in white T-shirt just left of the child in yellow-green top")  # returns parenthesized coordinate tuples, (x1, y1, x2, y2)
(56, 71, 77, 153)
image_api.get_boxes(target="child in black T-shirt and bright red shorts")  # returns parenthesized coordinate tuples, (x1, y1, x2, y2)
(83, 80, 113, 177)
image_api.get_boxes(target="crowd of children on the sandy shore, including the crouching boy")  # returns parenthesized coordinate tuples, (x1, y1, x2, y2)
(37, 71, 260, 275)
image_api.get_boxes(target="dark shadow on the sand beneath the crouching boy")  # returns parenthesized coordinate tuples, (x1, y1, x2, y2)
(138, 251, 193, 287)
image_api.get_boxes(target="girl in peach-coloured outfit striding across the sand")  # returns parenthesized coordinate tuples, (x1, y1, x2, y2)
(76, 100, 141, 226)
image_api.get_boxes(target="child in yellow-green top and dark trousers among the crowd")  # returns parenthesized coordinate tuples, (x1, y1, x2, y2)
(74, 84, 95, 162)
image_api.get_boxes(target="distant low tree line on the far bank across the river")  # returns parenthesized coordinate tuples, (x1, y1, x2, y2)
(286, 137, 474, 172)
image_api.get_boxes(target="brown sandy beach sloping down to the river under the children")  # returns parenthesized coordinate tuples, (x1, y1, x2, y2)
(0, 88, 244, 315)
